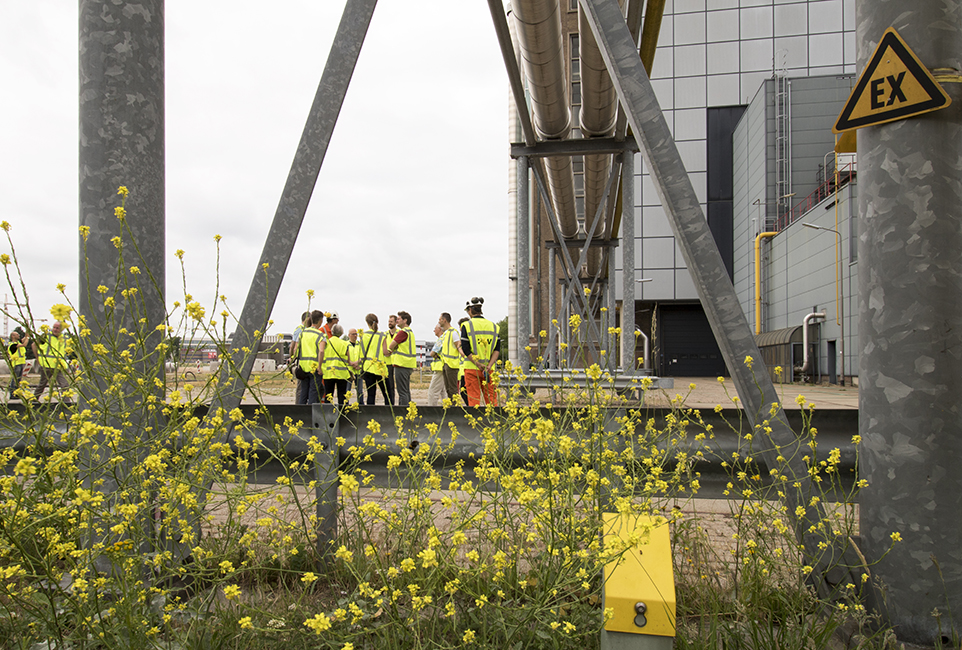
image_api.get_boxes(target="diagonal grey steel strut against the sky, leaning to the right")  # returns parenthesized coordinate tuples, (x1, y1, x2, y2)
(211, 0, 377, 411)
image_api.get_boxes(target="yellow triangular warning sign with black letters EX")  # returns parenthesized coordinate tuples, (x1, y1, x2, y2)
(832, 27, 952, 133)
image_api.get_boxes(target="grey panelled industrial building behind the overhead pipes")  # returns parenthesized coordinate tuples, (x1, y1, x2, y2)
(509, 0, 858, 381)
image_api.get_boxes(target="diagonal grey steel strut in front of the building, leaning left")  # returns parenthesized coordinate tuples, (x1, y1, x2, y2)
(581, 0, 858, 595)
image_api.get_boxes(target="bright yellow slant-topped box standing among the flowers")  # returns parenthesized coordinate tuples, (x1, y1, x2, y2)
(601, 513, 676, 650)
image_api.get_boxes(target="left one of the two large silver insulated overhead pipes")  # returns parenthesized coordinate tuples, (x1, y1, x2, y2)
(512, 0, 578, 238)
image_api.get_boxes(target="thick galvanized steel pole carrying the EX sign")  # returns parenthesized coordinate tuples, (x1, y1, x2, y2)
(856, 0, 962, 644)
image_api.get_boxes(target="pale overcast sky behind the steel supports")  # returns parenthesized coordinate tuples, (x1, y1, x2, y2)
(0, 0, 509, 340)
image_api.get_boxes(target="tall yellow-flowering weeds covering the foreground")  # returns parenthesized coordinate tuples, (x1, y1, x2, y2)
(0, 194, 899, 650)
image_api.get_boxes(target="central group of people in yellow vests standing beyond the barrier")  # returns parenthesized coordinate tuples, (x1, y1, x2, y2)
(290, 298, 498, 408)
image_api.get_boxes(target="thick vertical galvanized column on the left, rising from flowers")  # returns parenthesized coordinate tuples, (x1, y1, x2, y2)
(79, 0, 169, 571)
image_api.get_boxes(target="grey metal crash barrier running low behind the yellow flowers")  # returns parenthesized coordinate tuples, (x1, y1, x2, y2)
(0, 404, 858, 539)
